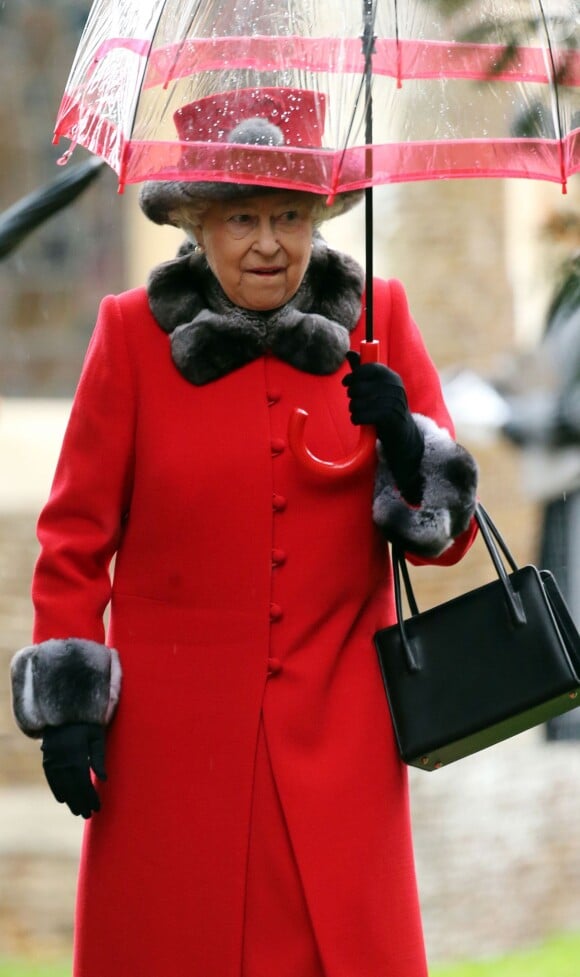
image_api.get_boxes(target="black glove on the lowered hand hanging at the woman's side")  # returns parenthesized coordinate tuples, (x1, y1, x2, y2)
(41, 723, 107, 818)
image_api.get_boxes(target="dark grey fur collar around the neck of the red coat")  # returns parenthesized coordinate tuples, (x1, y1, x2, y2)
(147, 234, 364, 386)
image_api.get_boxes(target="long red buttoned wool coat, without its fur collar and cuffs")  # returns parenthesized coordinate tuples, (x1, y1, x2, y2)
(33, 274, 468, 977)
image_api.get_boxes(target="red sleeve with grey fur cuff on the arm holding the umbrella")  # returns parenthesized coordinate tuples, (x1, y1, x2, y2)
(373, 280, 477, 564)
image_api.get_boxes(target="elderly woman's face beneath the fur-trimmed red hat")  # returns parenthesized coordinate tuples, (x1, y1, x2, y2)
(195, 191, 314, 312)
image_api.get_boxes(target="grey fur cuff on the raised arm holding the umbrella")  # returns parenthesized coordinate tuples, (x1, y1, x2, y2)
(373, 414, 477, 558)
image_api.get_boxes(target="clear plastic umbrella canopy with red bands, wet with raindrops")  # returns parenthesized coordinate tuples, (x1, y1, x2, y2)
(55, 0, 580, 195)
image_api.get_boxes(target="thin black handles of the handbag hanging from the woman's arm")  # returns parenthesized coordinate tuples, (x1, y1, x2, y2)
(392, 502, 526, 672)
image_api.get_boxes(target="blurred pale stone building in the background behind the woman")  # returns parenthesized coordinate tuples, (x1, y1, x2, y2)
(0, 0, 580, 960)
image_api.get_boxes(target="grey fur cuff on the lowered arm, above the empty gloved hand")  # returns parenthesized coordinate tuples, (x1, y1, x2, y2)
(11, 638, 121, 738)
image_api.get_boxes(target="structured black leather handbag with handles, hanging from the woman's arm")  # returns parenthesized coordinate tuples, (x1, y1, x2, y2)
(374, 505, 580, 770)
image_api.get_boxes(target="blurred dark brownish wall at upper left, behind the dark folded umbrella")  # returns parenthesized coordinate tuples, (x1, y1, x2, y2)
(0, 0, 126, 397)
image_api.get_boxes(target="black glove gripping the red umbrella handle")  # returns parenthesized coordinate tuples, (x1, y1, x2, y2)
(342, 352, 425, 505)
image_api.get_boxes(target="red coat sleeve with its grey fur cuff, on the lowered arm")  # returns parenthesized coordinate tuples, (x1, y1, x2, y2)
(11, 296, 136, 737)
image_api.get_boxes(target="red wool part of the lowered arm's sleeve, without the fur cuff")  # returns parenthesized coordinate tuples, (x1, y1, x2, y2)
(32, 296, 136, 642)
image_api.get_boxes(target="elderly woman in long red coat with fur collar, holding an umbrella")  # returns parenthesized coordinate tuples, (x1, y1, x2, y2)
(13, 89, 476, 977)
